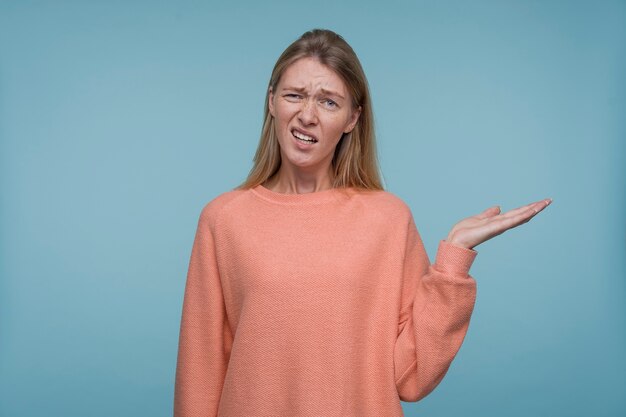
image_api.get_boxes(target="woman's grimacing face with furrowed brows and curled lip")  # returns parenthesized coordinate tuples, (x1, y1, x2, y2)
(269, 57, 361, 170)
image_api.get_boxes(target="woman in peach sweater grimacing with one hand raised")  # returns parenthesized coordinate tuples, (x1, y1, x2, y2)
(174, 29, 551, 417)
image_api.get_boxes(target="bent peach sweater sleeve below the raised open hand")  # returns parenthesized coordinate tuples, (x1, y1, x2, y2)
(394, 216, 477, 402)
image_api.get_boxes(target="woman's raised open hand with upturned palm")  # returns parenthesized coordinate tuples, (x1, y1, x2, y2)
(446, 198, 552, 249)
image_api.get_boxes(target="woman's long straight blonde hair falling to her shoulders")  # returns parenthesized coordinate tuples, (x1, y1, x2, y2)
(235, 29, 384, 190)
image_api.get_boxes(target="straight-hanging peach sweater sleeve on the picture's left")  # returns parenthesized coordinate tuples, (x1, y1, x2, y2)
(174, 207, 232, 417)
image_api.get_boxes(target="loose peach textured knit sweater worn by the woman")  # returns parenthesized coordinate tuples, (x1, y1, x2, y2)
(174, 185, 477, 417)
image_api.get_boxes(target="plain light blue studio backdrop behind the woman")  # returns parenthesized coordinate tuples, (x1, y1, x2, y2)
(0, 0, 626, 417)
